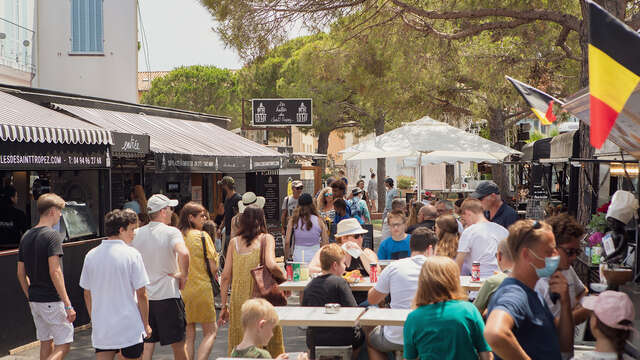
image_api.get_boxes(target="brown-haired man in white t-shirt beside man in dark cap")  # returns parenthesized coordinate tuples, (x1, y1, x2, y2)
(456, 199, 509, 277)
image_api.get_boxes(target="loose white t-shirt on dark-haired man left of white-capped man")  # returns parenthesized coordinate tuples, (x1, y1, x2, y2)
(80, 240, 149, 349)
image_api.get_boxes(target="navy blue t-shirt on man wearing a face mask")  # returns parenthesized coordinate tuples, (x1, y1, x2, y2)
(488, 277, 562, 360)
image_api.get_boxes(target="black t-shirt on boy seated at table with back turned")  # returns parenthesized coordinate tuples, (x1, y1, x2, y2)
(302, 274, 358, 346)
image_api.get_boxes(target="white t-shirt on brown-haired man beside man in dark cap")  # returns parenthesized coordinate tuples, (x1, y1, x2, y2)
(458, 222, 509, 277)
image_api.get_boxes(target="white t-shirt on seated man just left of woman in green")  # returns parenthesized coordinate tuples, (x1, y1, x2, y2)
(375, 255, 427, 344)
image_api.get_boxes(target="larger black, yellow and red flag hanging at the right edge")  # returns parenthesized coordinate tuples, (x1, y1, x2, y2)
(587, 0, 640, 149)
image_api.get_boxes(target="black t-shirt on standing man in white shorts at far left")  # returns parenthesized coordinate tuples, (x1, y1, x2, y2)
(18, 226, 63, 302)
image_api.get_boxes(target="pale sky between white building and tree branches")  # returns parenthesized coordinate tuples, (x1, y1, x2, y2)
(138, 0, 242, 71)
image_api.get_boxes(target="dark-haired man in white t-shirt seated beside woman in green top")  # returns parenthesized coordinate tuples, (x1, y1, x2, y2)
(367, 227, 438, 360)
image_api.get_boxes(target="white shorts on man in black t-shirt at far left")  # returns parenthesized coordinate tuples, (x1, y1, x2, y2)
(29, 301, 73, 345)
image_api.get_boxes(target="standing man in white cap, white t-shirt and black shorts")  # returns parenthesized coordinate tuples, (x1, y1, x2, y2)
(133, 194, 189, 360)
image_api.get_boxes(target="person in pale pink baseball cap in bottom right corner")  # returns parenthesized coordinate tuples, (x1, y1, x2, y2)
(574, 290, 636, 360)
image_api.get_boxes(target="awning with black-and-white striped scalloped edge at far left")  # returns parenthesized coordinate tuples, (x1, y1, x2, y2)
(0, 91, 113, 145)
